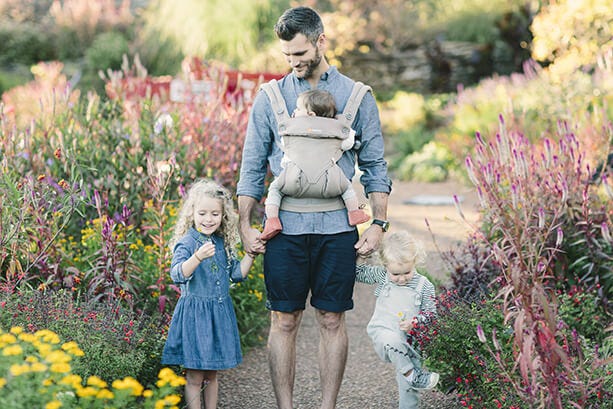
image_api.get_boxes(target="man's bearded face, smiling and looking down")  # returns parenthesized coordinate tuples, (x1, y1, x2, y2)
(280, 34, 325, 80)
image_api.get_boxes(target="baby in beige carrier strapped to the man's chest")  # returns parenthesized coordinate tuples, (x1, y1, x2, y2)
(260, 89, 370, 240)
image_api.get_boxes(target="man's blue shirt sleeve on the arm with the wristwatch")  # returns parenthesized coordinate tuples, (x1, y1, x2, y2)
(355, 92, 392, 196)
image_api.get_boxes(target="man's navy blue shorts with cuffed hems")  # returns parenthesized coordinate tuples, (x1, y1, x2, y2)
(264, 230, 358, 312)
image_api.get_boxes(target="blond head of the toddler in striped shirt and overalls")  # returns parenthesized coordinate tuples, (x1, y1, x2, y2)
(380, 230, 425, 285)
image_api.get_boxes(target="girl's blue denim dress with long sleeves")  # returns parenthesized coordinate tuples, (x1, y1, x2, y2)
(162, 228, 243, 370)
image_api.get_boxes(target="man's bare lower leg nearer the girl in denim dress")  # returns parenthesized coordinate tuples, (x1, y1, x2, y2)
(268, 310, 302, 409)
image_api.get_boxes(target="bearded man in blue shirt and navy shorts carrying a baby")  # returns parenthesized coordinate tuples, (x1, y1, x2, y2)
(237, 7, 391, 409)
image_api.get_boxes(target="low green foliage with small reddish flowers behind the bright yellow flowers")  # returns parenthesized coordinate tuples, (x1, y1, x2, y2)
(0, 290, 166, 385)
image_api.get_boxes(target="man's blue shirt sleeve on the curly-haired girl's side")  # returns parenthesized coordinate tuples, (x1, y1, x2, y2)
(236, 91, 274, 201)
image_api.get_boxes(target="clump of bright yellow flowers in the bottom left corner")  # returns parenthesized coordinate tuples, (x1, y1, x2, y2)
(0, 326, 185, 409)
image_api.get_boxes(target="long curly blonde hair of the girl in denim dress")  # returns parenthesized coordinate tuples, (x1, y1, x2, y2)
(169, 179, 240, 256)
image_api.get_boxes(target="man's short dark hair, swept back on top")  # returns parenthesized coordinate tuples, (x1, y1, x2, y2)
(275, 7, 324, 45)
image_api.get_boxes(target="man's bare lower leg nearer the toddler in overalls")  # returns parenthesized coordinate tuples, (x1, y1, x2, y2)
(316, 310, 349, 409)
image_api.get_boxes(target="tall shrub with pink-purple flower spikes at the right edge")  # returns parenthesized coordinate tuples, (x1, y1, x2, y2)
(454, 118, 612, 408)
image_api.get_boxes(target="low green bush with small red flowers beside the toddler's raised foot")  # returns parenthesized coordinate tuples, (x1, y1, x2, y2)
(418, 291, 523, 408)
